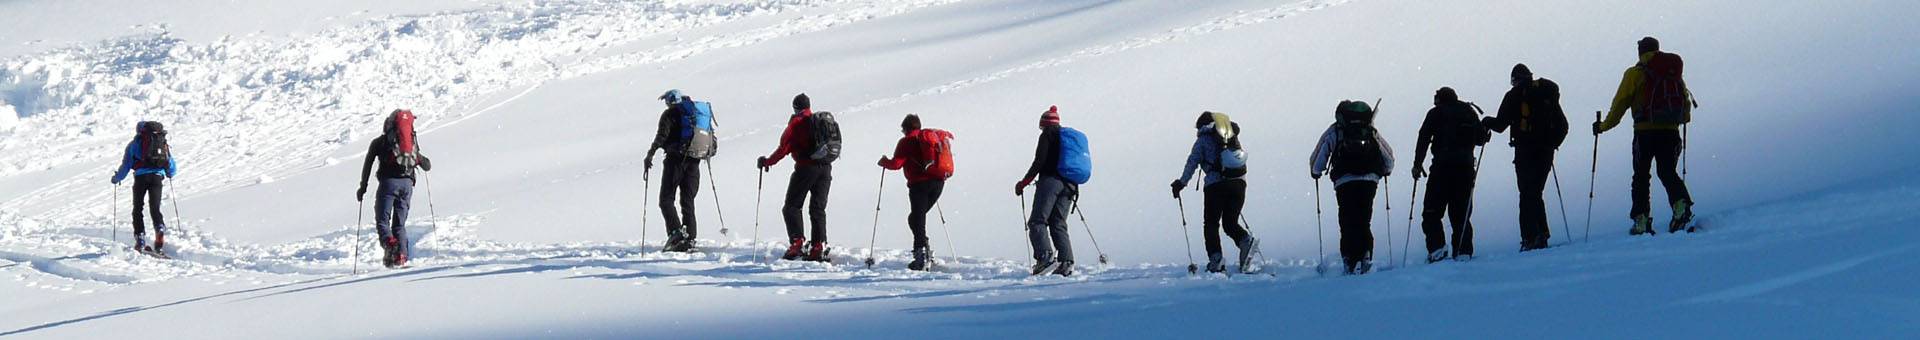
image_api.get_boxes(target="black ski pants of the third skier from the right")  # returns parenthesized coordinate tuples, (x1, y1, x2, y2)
(1421, 159, 1478, 255)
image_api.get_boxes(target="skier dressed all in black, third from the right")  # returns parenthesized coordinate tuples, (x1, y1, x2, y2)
(1413, 86, 1490, 263)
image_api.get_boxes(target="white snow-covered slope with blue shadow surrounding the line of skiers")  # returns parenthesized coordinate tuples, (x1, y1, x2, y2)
(0, 0, 1920, 338)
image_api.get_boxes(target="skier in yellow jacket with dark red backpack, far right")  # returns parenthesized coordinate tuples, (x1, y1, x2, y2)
(1594, 36, 1695, 234)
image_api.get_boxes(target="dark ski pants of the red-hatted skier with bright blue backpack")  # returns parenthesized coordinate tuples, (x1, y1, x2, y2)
(1027, 175, 1079, 263)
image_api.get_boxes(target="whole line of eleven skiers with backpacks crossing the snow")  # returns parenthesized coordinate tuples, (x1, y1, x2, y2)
(111, 36, 1697, 277)
